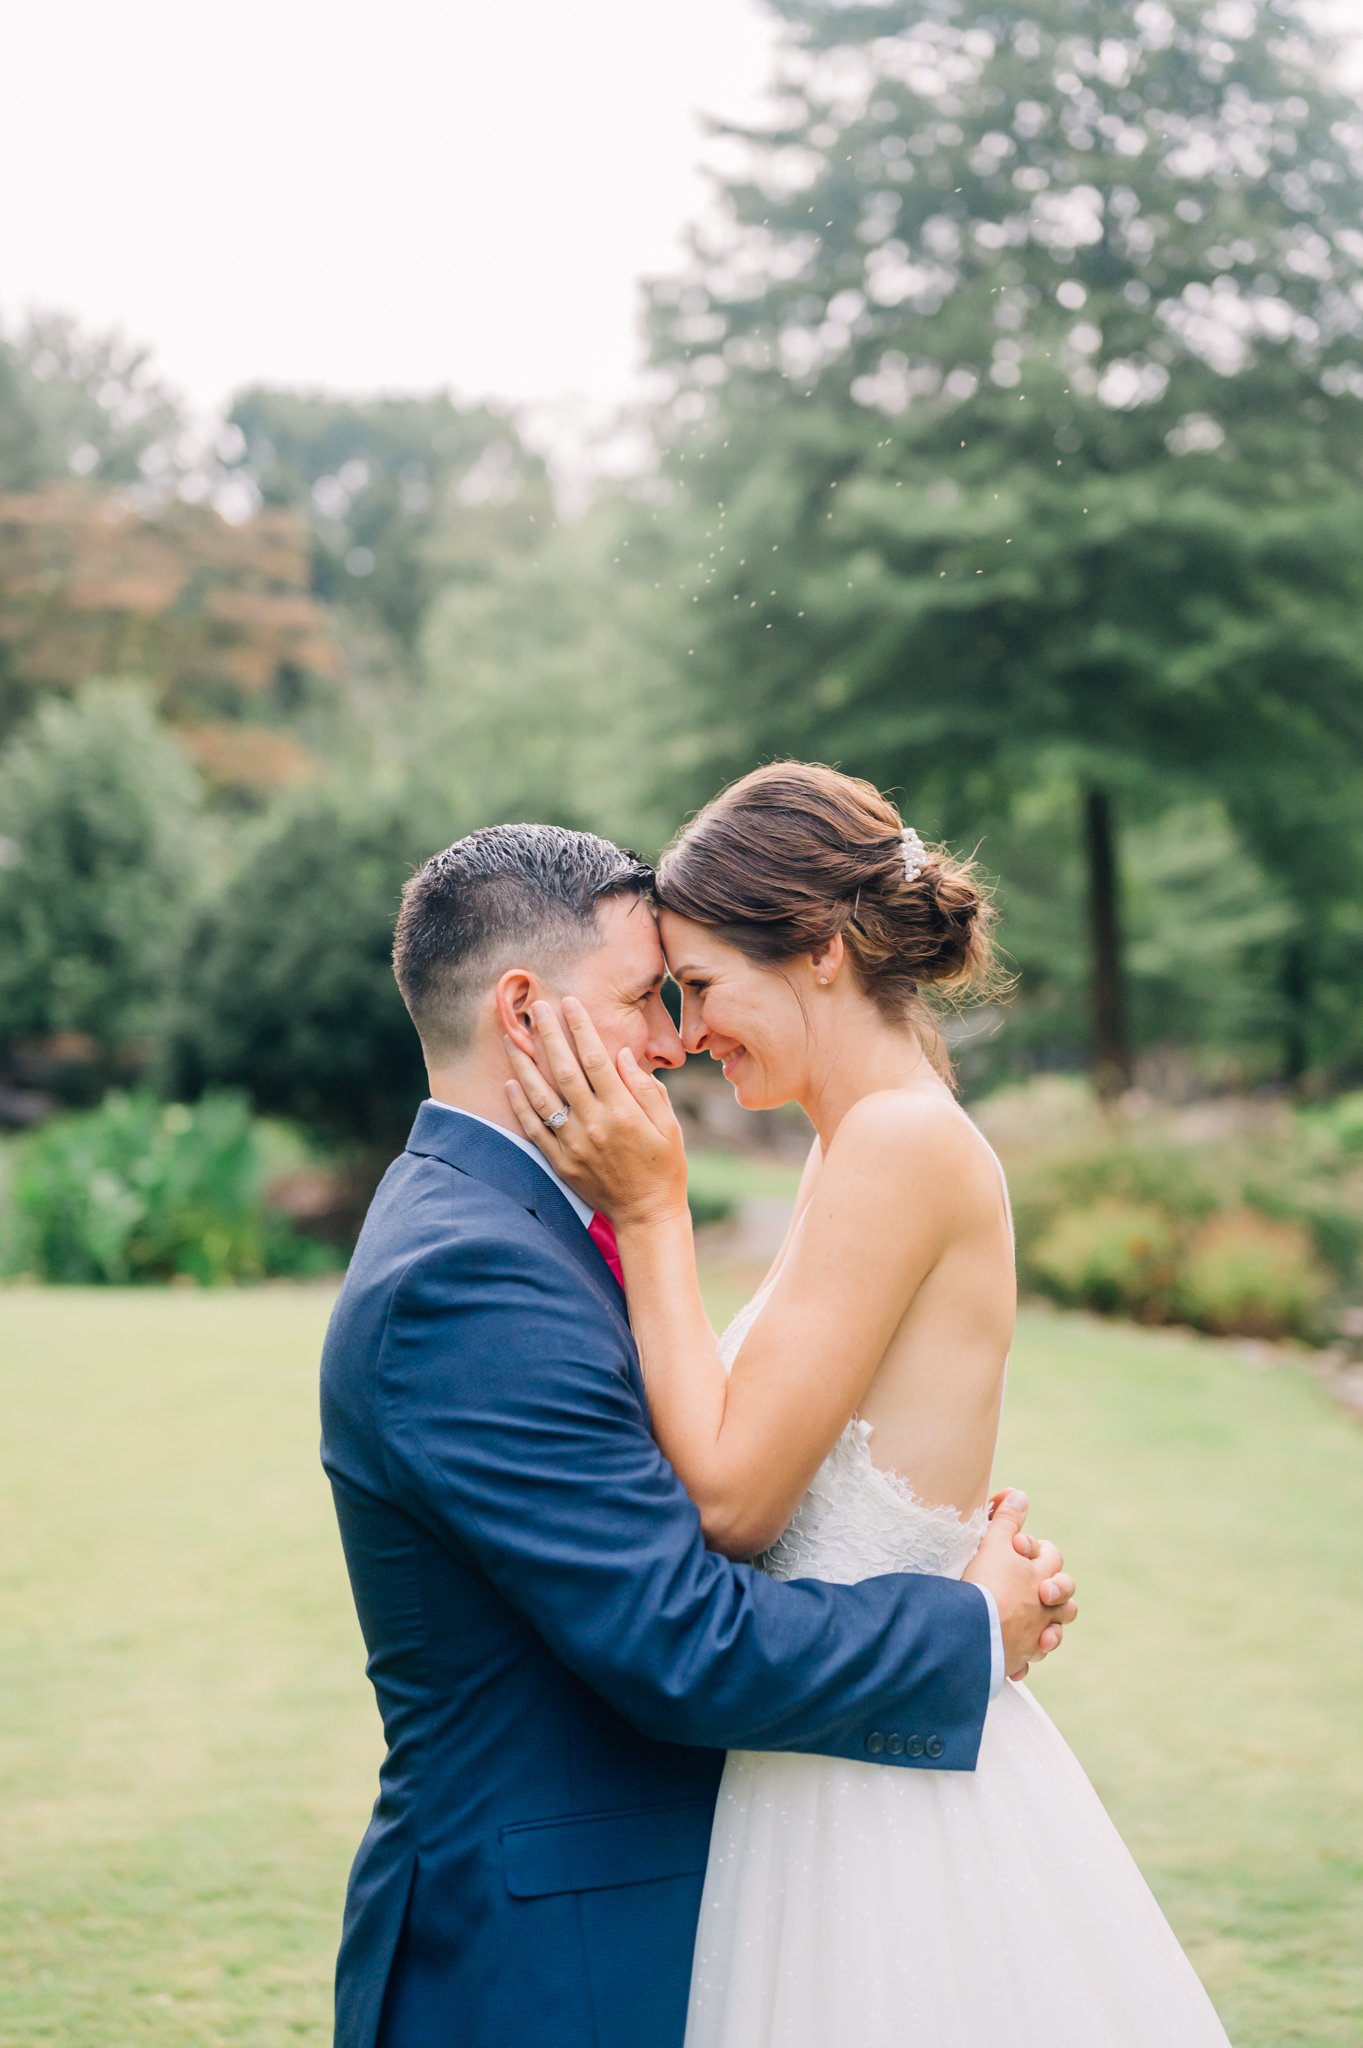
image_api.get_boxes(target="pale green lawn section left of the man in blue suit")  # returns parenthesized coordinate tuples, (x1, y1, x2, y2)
(0, 1288, 377, 2048)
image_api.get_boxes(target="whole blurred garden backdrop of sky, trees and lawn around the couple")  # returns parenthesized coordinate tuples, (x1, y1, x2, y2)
(0, 0, 1363, 2048)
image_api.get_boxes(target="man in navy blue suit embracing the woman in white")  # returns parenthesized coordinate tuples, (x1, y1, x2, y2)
(321, 825, 1072, 2048)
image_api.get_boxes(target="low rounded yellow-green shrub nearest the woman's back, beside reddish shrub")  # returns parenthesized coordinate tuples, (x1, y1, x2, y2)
(1031, 1196, 1179, 1323)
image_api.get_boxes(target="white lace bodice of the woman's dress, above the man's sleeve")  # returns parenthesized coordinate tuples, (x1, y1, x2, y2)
(720, 1288, 988, 1585)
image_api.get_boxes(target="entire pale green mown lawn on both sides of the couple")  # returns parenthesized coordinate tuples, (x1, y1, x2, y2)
(0, 1276, 1363, 2048)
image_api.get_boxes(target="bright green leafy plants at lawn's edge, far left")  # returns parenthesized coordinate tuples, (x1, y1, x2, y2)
(6, 1094, 329, 1286)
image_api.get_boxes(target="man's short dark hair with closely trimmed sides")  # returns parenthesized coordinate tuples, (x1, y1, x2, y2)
(393, 825, 653, 1059)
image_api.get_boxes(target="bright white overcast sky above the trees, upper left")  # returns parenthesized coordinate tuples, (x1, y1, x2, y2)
(0, 0, 774, 468)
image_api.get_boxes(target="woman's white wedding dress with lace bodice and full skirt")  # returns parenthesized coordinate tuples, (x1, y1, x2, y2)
(686, 1288, 1228, 2048)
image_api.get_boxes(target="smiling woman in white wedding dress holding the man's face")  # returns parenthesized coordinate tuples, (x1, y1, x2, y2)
(510, 762, 1226, 2048)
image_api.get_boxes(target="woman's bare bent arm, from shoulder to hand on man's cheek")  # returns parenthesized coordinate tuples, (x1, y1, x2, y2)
(512, 1004, 972, 1556)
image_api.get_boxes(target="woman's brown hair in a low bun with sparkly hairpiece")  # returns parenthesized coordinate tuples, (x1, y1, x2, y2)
(657, 762, 1007, 1071)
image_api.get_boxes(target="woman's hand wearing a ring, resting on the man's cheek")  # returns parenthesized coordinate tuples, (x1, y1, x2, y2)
(505, 995, 686, 1229)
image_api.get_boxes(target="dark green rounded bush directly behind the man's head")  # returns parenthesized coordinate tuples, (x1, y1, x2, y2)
(174, 788, 437, 1147)
